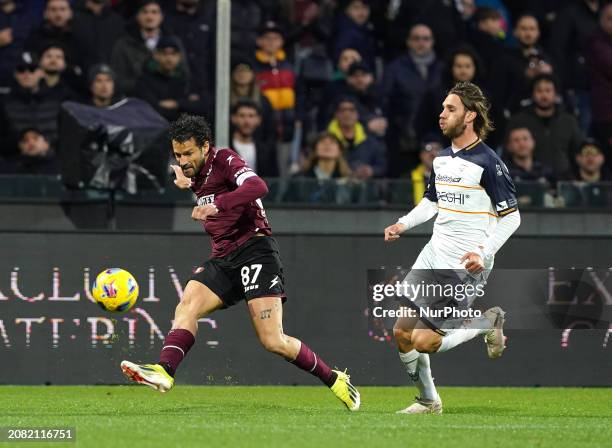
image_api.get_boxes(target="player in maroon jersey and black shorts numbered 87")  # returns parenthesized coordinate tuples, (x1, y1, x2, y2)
(121, 115, 360, 411)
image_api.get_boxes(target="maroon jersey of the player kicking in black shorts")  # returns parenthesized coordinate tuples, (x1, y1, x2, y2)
(191, 147, 272, 258)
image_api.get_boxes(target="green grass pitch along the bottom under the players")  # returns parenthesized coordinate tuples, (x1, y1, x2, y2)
(0, 385, 612, 448)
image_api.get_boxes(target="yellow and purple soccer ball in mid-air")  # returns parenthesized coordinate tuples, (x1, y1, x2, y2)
(91, 268, 138, 313)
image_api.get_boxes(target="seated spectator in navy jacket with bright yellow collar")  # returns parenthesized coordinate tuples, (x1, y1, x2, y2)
(327, 97, 387, 179)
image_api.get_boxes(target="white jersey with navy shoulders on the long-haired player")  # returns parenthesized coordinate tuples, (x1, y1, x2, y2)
(413, 139, 517, 269)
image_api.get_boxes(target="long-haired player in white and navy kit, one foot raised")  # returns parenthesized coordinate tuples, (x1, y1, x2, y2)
(385, 82, 520, 414)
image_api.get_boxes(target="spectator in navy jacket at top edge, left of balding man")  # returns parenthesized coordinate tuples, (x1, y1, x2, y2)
(333, 0, 377, 70)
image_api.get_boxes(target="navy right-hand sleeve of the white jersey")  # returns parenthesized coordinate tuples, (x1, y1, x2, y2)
(480, 157, 518, 216)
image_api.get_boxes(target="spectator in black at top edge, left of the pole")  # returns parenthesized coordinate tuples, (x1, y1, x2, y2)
(72, 0, 125, 73)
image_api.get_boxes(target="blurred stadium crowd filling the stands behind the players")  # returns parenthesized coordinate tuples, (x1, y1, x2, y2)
(0, 0, 612, 198)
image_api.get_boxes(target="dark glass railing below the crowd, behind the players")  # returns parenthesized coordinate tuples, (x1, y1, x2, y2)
(0, 175, 612, 210)
